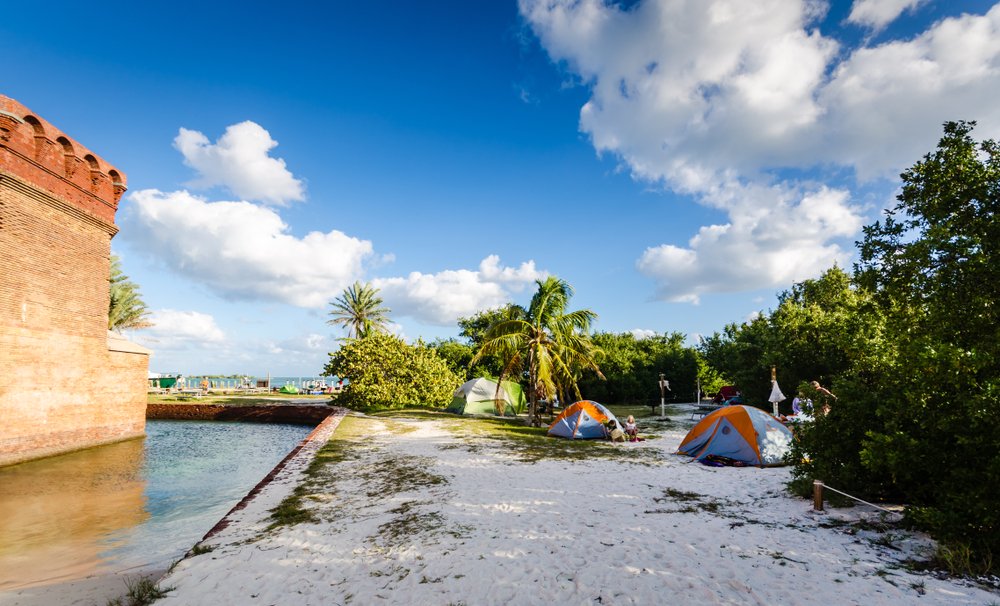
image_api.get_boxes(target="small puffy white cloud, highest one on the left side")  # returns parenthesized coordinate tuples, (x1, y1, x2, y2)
(174, 120, 305, 206)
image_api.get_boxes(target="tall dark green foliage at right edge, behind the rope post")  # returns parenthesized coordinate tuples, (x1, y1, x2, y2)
(792, 122, 1000, 574)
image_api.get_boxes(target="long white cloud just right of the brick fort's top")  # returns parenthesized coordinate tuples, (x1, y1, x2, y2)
(122, 189, 373, 308)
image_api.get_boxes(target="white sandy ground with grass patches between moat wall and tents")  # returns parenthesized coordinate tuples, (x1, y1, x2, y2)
(158, 421, 1000, 606)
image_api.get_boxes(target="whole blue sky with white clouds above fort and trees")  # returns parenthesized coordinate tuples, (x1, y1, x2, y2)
(0, 0, 1000, 375)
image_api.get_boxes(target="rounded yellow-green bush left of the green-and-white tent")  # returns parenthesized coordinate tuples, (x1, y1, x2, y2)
(323, 333, 461, 410)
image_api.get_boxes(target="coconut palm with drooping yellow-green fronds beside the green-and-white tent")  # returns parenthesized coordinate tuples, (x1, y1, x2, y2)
(473, 276, 604, 427)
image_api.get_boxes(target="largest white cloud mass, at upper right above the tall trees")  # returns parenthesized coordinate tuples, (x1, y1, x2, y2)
(518, 0, 1000, 302)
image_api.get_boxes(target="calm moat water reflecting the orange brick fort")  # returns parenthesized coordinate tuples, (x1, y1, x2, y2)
(0, 421, 312, 591)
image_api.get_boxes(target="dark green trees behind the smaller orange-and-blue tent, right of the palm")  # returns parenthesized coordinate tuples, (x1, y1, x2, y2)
(579, 332, 714, 404)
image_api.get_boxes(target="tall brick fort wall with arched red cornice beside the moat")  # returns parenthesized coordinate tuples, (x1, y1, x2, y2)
(0, 95, 149, 466)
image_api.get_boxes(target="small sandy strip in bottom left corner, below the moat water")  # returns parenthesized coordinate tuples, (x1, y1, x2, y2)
(0, 569, 166, 606)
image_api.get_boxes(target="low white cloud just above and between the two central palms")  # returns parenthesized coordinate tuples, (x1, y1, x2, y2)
(372, 255, 548, 326)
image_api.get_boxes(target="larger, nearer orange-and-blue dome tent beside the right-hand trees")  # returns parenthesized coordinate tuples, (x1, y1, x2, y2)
(677, 406, 794, 467)
